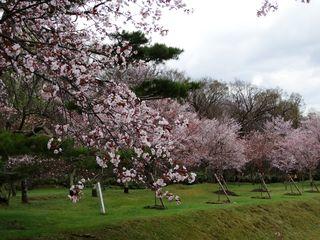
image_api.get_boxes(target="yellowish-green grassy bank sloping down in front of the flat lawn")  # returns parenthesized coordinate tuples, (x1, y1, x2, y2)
(73, 201, 320, 240)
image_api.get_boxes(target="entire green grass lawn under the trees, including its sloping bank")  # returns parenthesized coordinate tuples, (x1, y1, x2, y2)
(0, 184, 320, 239)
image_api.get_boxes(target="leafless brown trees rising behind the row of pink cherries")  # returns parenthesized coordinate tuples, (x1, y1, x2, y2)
(188, 79, 303, 134)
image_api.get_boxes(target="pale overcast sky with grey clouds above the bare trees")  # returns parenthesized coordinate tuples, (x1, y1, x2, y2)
(153, 0, 320, 114)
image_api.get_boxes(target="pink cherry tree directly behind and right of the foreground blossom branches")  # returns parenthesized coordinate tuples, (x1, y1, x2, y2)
(153, 99, 246, 181)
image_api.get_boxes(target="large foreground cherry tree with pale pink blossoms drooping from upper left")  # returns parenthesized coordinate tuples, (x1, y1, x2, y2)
(0, 0, 192, 206)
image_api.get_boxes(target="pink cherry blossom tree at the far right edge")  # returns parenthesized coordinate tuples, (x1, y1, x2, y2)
(266, 115, 320, 190)
